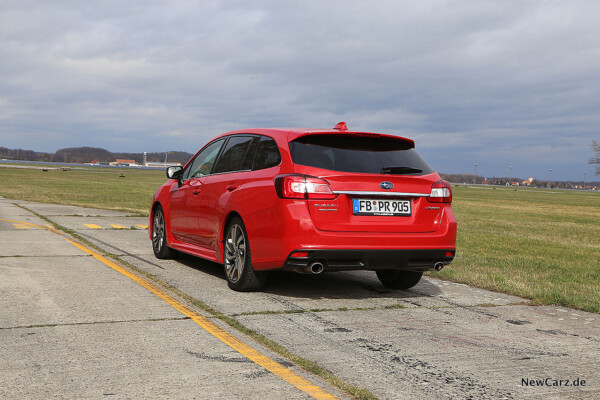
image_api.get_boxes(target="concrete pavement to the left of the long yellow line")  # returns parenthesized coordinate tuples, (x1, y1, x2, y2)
(0, 199, 344, 399)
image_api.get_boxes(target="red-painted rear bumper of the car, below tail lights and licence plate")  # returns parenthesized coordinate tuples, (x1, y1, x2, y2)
(242, 200, 456, 271)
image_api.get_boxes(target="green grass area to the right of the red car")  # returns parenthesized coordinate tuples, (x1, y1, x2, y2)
(431, 186, 600, 313)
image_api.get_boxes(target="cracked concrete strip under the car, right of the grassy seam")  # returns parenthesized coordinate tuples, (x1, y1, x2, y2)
(0, 203, 600, 399)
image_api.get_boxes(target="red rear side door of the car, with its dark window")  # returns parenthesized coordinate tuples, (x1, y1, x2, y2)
(199, 135, 258, 251)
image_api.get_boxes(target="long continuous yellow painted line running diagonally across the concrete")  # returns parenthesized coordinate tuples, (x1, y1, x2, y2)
(0, 218, 339, 400)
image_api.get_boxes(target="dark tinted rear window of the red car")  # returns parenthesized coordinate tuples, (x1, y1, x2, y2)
(290, 134, 433, 175)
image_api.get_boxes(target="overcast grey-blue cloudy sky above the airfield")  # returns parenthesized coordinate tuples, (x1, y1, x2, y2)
(0, 0, 600, 180)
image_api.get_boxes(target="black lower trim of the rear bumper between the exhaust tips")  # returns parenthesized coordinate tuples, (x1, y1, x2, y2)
(283, 249, 455, 272)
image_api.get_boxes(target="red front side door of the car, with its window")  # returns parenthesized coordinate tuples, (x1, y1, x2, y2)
(169, 139, 225, 245)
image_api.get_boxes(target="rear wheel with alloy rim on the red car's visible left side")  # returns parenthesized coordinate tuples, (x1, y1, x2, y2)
(223, 217, 267, 292)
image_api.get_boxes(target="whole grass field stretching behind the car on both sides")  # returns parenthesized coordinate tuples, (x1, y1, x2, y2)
(0, 166, 600, 313)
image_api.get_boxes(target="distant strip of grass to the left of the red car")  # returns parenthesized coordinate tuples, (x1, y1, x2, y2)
(0, 165, 167, 215)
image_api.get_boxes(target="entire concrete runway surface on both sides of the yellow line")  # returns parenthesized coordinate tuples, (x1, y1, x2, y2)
(0, 199, 600, 399)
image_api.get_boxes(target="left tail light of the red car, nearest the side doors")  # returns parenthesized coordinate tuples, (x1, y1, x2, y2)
(275, 175, 337, 200)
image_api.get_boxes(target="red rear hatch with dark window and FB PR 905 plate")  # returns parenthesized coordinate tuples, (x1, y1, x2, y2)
(290, 133, 443, 233)
